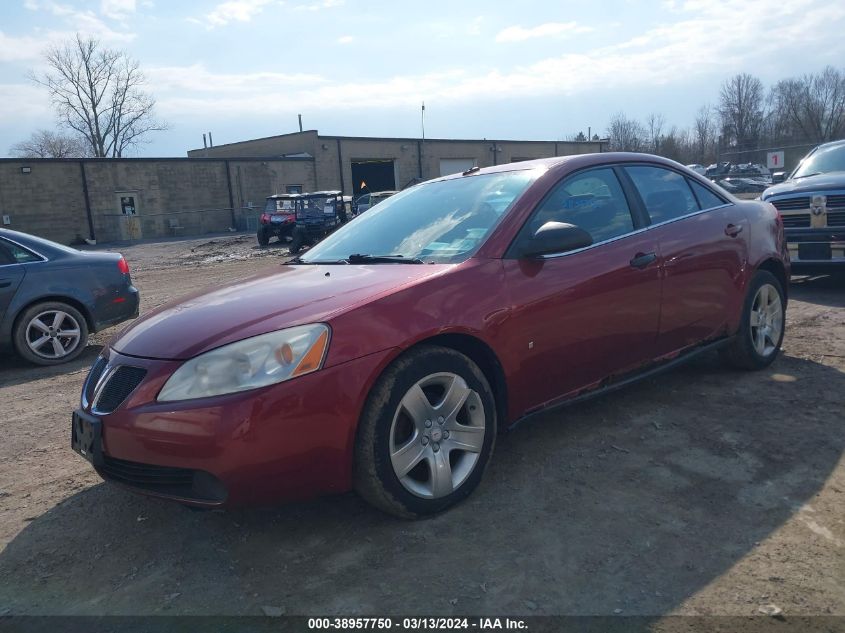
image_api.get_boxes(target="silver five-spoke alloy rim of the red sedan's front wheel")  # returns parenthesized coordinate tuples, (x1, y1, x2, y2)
(390, 372, 487, 499)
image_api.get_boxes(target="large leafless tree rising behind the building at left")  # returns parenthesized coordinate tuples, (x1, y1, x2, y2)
(30, 34, 167, 158)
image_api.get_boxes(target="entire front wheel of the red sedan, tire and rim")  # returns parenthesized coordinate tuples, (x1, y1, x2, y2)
(354, 346, 496, 518)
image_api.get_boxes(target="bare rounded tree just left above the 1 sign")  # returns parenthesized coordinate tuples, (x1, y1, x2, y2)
(719, 73, 763, 150)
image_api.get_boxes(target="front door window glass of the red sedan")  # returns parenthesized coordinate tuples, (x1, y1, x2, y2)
(528, 167, 634, 244)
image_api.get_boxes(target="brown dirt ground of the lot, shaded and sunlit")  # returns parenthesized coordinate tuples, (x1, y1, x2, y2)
(0, 235, 845, 616)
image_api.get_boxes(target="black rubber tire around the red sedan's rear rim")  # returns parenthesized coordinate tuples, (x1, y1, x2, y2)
(721, 270, 786, 370)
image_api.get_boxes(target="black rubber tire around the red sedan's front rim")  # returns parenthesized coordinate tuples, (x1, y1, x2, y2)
(353, 346, 496, 519)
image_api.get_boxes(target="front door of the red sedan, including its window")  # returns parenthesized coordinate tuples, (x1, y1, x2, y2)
(503, 167, 660, 414)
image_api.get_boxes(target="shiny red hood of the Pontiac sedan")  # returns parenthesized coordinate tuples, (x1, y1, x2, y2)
(110, 264, 451, 360)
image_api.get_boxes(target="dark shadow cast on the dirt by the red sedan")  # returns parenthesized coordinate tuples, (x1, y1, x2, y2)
(0, 356, 845, 616)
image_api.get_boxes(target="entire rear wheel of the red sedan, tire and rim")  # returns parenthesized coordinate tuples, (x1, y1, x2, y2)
(722, 270, 786, 369)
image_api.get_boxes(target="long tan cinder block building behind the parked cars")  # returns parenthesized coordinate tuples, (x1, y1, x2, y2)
(0, 130, 606, 244)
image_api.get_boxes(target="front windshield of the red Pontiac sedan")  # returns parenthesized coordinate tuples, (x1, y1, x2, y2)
(301, 170, 540, 263)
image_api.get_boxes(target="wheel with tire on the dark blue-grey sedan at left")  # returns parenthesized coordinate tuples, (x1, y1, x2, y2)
(12, 301, 88, 365)
